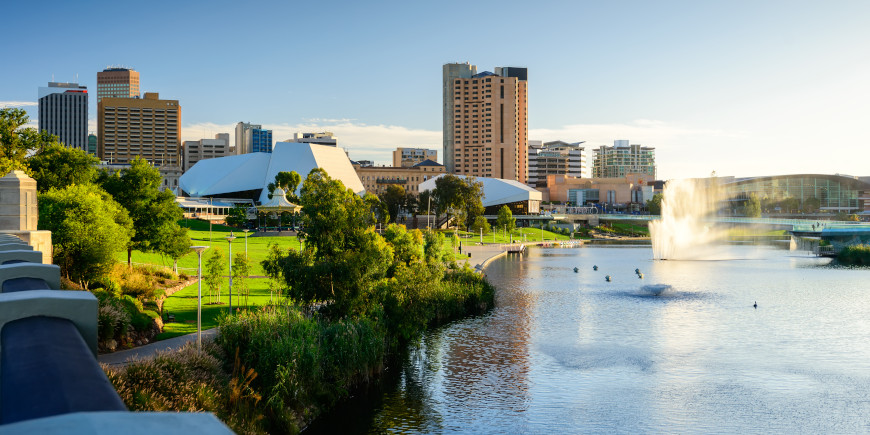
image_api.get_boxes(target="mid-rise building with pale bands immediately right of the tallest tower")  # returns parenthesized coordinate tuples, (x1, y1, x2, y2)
(528, 140, 586, 187)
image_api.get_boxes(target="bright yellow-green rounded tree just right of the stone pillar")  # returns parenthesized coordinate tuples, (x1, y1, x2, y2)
(38, 185, 133, 288)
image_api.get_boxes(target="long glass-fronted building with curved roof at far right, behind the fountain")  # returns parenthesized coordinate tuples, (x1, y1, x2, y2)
(725, 175, 870, 212)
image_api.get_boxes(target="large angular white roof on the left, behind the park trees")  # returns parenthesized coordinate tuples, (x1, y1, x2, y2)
(179, 142, 365, 203)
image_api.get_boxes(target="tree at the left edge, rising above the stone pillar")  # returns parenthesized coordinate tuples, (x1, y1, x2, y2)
(0, 108, 58, 176)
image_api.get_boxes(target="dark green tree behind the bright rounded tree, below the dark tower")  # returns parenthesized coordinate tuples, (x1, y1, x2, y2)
(27, 143, 99, 192)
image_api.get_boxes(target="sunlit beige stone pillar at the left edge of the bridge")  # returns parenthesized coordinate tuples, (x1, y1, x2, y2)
(0, 171, 52, 264)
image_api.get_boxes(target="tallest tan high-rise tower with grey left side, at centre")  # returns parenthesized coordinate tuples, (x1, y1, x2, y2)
(444, 64, 528, 183)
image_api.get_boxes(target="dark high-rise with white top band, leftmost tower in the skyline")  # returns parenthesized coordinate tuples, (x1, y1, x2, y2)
(39, 82, 88, 151)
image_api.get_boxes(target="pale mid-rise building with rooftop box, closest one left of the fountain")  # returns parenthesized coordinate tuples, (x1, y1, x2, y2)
(592, 140, 656, 180)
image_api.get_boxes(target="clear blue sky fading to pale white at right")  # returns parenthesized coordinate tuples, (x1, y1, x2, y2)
(0, 0, 870, 179)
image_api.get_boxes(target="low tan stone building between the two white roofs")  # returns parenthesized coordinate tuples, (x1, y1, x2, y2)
(354, 160, 447, 195)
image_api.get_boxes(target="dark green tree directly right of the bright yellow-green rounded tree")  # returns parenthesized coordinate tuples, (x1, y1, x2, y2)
(98, 157, 182, 265)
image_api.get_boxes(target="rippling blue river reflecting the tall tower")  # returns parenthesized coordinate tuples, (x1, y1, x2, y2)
(307, 246, 870, 433)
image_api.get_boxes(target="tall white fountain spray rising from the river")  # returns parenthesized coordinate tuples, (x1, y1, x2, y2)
(649, 178, 726, 260)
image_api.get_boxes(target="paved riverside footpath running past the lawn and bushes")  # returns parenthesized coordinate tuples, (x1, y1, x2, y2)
(97, 244, 505, 367)
